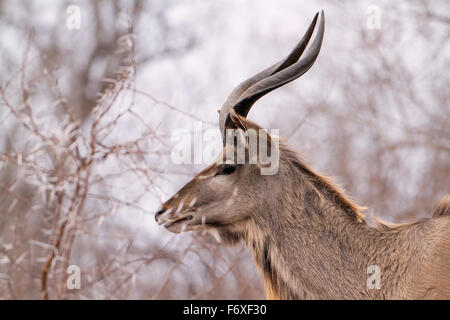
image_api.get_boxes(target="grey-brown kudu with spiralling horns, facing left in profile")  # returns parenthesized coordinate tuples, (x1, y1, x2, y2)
(155, 12, 450, 299)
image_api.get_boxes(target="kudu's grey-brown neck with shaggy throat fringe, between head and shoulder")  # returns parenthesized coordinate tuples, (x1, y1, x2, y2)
(247, 149, 396, 299)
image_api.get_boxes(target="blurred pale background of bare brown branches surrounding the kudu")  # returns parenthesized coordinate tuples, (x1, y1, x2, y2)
(0, 0, 450, 299)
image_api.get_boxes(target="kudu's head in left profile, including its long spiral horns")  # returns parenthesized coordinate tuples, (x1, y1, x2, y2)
(155, 11, 324, 242)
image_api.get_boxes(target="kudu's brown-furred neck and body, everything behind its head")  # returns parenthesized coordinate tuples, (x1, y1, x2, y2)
(217, 149, 450, 299)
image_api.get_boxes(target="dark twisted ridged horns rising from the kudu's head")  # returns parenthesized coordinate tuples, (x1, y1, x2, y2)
(219, 10, 325, 145)
